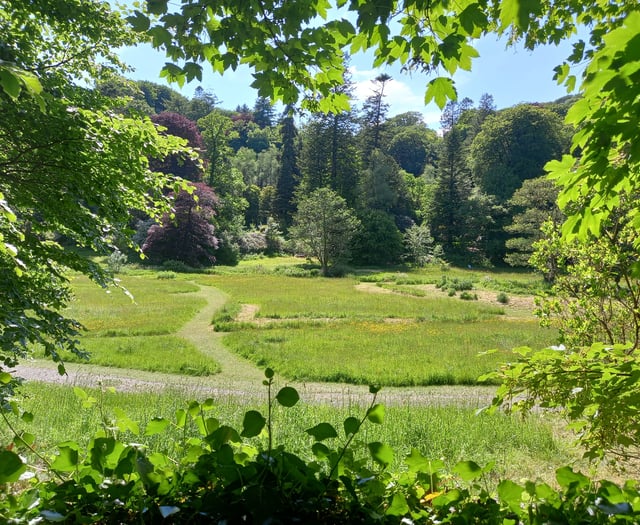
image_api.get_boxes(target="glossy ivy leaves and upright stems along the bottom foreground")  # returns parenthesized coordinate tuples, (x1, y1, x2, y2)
(5, 369, 640, 525)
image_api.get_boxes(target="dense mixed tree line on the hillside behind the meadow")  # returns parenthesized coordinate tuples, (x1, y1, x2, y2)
(98, 74, 574, 273)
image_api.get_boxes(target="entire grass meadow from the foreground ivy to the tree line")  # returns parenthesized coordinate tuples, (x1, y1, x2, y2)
(11, 259, 576, 486)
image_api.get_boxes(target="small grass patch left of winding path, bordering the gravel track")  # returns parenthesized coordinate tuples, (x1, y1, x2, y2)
(62, 335, 220, 376)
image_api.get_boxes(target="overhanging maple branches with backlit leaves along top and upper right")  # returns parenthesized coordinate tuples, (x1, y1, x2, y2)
(136, 0, 640, 249)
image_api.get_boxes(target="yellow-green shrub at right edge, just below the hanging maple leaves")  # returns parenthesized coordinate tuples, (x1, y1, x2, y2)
(531, 211, 640, 350)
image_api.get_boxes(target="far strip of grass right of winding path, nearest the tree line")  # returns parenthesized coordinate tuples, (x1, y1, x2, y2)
(199, 274, 504, 322)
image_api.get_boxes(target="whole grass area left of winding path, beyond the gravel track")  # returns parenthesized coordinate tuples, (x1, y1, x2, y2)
(36, 272, 219, 375)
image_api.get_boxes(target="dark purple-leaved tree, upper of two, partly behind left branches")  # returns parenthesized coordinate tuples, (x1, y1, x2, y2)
(150, 111, 204, 182)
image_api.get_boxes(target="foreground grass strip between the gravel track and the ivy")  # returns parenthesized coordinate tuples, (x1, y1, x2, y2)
(7, 382, 575, 479)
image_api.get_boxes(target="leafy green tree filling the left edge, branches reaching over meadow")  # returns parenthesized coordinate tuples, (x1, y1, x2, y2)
(0, 0, 186, 380)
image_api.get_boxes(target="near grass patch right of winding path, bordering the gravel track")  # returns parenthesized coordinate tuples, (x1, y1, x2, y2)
(223, 316, 555, 386)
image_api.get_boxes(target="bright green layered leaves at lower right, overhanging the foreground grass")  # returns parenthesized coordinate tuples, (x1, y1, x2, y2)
(485, 343, 640, 460)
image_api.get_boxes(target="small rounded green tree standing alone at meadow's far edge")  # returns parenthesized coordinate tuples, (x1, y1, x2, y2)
(289, 188, 359, 275)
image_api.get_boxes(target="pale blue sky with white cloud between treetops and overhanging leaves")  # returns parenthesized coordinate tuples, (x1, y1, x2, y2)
(120, 26, 584, 129)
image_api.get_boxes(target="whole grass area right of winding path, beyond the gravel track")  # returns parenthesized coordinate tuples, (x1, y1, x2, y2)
(203, 269, 557, 386)
